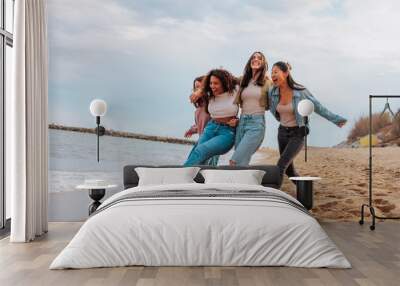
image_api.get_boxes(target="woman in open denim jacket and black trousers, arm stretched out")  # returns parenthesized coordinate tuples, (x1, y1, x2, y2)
(268, 62, 347, 187)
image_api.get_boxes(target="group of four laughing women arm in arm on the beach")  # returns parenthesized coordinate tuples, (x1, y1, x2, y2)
(185, 52, 347, 185)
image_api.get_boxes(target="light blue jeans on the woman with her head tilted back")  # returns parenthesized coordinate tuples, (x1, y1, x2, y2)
(231, 114, 265, 166)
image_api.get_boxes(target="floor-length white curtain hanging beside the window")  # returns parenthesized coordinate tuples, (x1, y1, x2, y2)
(6, 0, 48, 242)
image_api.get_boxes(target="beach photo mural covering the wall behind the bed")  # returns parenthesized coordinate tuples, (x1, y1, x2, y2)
(48, 0, 400, 220)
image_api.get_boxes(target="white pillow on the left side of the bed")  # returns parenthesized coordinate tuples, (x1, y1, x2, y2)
(135, 167, 200, 186)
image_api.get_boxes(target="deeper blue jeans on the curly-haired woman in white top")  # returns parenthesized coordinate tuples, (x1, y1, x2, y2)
(184, 120, 235, 166)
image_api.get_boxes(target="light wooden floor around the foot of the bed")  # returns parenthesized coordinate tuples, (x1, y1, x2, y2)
(0, 221, 400, 286)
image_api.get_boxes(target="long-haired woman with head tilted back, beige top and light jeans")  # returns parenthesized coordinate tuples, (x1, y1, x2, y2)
(229, 52, 272, 166)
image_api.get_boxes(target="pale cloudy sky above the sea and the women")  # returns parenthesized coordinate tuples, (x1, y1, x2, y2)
(48, 0, 400, 146)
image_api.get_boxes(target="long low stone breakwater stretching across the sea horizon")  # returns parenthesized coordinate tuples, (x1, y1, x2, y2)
(49, 123, 195, 145)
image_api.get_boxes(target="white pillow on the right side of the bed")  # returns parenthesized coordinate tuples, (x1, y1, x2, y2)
(200, 169, 265, 185)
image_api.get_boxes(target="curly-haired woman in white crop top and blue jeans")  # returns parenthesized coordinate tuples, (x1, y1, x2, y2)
(184, 69, 239, 166)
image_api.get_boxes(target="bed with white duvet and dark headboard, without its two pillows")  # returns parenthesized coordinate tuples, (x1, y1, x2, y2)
(50, 165, 351, 269)
